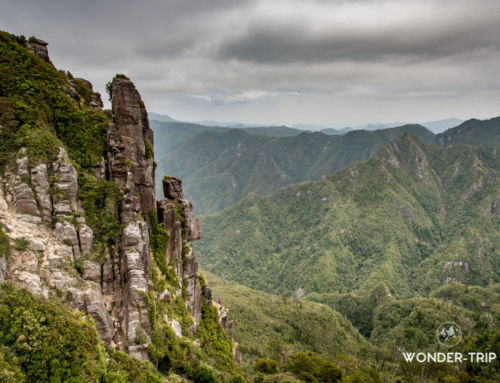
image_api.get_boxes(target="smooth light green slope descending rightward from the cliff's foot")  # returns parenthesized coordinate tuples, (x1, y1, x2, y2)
(205, 273, 368, 365)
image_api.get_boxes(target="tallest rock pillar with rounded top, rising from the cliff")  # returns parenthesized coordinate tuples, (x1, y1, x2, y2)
(105, 77, 156, 359)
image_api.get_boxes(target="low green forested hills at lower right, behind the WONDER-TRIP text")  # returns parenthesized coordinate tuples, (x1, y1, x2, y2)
(207, 273, 500, 382)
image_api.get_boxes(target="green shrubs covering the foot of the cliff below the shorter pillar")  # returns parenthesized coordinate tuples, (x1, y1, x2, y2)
(147, 259, 242, 382)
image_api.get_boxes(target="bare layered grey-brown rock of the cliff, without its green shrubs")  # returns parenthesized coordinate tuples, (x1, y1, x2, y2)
(0, 73, 221, 360)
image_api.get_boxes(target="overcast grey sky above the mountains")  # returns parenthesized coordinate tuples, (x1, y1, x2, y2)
(0, 0, 500, 128)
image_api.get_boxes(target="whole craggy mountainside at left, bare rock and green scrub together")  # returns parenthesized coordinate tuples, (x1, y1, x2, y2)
(0, 32, 240, 380)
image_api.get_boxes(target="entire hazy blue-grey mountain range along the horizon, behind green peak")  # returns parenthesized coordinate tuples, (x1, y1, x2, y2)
(151, 118, 500, 214)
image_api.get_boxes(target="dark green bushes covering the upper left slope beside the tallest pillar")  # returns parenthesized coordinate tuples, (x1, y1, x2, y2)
(0, 32, 109, 168)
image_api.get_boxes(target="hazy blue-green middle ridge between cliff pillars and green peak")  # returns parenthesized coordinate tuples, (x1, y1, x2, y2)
(158, 125, 434, 213)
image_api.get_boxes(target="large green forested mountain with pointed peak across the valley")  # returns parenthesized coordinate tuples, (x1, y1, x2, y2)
(198, 135, 500, 296)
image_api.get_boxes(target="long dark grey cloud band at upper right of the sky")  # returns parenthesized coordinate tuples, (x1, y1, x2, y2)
(217, 7, 500, 64)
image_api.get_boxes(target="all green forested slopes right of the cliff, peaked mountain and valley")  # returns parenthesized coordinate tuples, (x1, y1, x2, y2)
(195, 135, 500, 383)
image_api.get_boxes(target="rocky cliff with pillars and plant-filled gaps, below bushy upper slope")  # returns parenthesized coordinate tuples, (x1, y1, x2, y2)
(0, 36, 238, 376)
